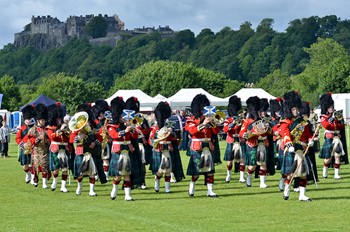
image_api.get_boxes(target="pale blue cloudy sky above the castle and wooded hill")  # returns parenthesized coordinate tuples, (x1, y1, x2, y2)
(0, 0, 350, 49)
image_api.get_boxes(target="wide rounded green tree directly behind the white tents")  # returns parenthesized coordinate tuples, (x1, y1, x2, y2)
(110, 61, 242, 97)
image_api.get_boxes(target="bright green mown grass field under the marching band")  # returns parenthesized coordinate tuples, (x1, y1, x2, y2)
(0, 133, 350, 232)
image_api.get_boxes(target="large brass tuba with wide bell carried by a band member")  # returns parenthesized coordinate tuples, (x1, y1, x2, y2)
(68, 111, 91, 144)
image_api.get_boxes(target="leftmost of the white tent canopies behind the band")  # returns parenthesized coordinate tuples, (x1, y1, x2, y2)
(106, 89, 159, 111)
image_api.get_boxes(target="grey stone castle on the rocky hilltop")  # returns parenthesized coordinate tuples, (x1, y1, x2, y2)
(14, 14, 174, 50)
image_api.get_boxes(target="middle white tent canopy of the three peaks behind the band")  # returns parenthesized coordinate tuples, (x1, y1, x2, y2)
(168, 88, 228, 109)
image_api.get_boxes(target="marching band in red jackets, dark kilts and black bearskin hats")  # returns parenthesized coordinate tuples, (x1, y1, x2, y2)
(16, 91, 348, 202)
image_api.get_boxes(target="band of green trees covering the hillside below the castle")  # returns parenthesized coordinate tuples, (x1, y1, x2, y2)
(0, 15, 350, 110)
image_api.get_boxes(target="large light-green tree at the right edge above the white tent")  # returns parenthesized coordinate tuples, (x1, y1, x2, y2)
(293, 38, 350, 105)
